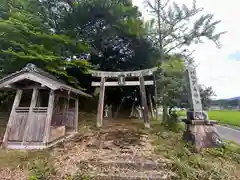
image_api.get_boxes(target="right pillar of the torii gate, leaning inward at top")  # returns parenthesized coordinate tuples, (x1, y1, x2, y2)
(139, 75, 150, 128)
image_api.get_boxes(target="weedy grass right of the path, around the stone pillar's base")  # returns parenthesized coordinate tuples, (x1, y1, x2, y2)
(151, 120, 240, 180)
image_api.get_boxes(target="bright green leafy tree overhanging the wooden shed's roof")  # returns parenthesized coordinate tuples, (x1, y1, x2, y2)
(0, 0, 89, 87)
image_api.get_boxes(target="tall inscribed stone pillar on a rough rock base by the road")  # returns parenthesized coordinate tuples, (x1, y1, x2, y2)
(183, 65, 223, 152)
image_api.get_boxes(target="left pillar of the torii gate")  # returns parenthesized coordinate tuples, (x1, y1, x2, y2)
(97, 77, 105, 127)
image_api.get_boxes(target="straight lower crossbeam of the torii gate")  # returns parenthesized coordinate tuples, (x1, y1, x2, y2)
(92, 81, 154, 87)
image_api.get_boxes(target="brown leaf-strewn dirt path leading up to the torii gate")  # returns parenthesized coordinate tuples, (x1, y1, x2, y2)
(53, 120, 173, 180)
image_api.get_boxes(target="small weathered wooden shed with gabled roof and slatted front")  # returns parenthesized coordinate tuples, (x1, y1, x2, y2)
(0, 64, 91, 149)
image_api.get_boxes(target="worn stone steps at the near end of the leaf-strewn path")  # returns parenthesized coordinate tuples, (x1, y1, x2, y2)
(79, 161, 174, 180)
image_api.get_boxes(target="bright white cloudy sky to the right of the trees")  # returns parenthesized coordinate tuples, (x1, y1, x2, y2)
(133, 0, 240, 99)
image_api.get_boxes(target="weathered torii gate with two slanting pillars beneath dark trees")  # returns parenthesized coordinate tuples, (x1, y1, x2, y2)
(90, 67, 157, 128)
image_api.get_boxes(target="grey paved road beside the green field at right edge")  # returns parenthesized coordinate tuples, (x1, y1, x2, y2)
(215, 125, 240, 144)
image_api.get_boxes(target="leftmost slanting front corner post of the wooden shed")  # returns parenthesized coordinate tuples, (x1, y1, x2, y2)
(2, 89, 22, 147)
